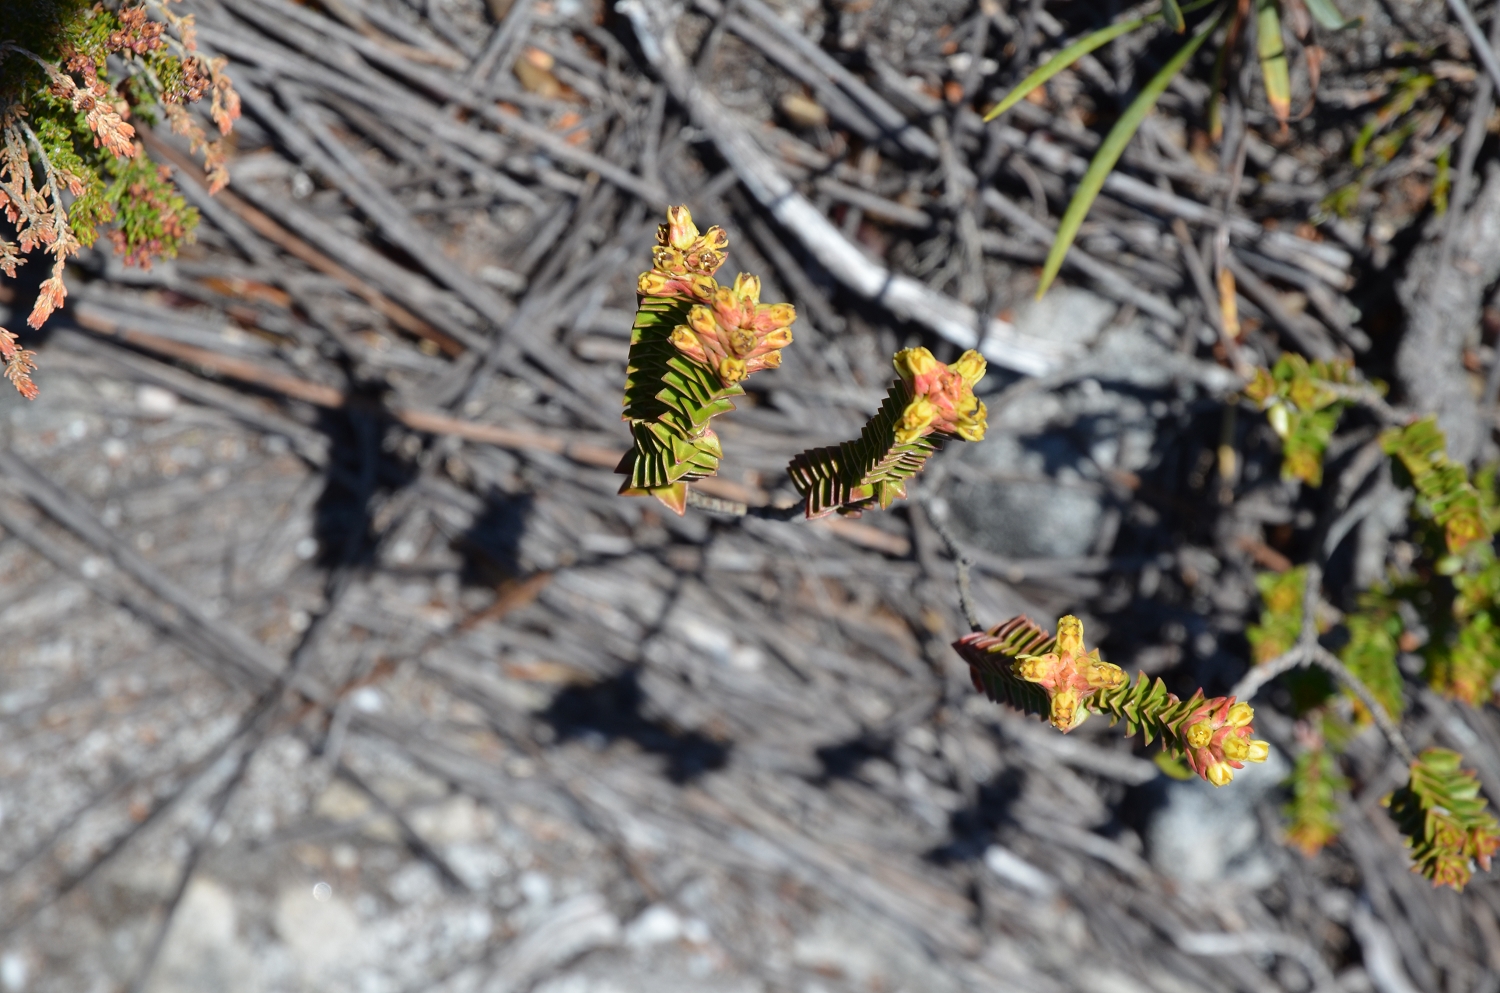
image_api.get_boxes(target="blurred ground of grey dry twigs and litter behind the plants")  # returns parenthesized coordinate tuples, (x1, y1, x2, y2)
(0, 0, 1500, 993)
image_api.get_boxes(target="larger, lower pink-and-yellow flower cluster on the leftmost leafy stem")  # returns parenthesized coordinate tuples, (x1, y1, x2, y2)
(672, 273, 797, 386)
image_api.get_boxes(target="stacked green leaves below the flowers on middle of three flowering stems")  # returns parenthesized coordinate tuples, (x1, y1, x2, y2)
(786, 380, 947, 518)
